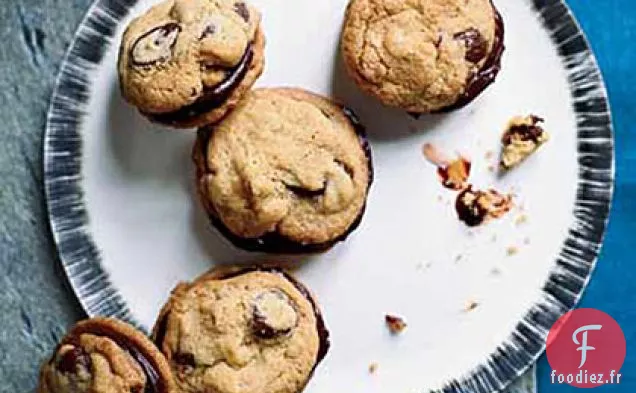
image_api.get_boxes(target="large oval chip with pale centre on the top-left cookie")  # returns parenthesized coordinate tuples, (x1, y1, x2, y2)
(130, 23, 181, 66)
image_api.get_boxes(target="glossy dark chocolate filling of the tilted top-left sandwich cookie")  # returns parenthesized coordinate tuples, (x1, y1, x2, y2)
(143, 44, 254, 125)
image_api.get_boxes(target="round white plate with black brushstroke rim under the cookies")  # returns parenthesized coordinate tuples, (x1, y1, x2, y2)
(45, 0, 613, 393)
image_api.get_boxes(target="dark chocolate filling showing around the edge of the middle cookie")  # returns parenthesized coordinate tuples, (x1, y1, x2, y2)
(195, 106, 373, 254)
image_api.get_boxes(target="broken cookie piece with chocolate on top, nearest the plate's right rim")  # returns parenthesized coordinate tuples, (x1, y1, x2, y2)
(499, 115, 549, 170)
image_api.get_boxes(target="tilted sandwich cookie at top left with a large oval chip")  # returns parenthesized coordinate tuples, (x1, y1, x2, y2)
(118, 0, 265, 128)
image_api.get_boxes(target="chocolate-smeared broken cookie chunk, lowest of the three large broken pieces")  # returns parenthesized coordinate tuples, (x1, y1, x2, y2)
(455, 185, 513, 227)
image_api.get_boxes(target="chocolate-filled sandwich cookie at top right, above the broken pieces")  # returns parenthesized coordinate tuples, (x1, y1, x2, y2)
(341, 0, 504, 114)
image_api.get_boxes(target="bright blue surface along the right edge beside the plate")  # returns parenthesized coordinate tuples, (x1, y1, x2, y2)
(538, 0, 636, 393)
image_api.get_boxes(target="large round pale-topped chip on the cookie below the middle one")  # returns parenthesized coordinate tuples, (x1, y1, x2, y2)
(252, 289, 298, 339)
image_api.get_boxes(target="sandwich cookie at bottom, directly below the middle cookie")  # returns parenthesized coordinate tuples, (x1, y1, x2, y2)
(153, 267, 329, 393)
